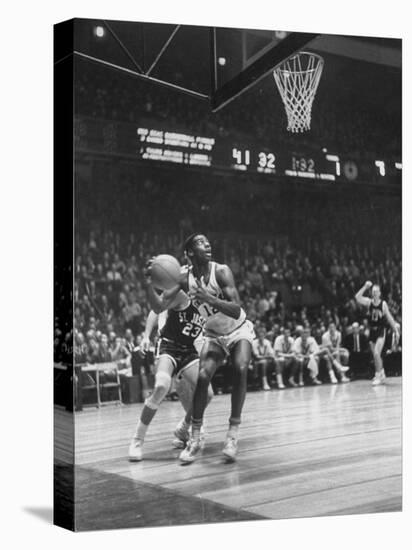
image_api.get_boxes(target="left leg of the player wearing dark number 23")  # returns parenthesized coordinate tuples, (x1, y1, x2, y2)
(129, 355, 175, 462)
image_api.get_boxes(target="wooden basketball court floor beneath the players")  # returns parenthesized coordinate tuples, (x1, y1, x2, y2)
(64, 378, 402, 530)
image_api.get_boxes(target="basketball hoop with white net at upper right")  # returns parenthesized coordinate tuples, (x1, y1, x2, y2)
(273, 52, 323, 132)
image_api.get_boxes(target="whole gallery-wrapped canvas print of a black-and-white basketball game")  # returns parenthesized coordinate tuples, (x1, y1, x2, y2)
(54, 19, 402, 531)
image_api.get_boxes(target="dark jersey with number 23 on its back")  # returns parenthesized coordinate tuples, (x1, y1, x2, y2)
(160, 302, 205, 348)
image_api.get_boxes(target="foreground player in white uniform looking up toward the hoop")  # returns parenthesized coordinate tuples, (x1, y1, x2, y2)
(180, 233, 255, 464)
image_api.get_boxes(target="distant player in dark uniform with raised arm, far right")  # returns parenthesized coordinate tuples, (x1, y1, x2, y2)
(355, 281, 399, 386)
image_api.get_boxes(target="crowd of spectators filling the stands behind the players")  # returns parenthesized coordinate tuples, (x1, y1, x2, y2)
(65, 165, 402, 392)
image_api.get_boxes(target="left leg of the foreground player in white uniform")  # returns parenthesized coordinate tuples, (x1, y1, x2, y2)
(179, 339, 225, 464)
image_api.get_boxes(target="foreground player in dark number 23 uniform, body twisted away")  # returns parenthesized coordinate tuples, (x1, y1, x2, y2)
(129, 267, 213, 462)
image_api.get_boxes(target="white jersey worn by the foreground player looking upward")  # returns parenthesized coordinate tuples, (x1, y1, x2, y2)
(187, 262, 246, 336)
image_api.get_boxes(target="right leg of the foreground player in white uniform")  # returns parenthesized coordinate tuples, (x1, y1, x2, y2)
(223, 339, 252, 460)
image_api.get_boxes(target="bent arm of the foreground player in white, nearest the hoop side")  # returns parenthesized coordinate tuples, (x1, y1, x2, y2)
(194, 265, 241, 319)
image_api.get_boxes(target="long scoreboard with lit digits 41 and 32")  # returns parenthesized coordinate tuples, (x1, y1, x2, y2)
(75, 117, 402, 183)
